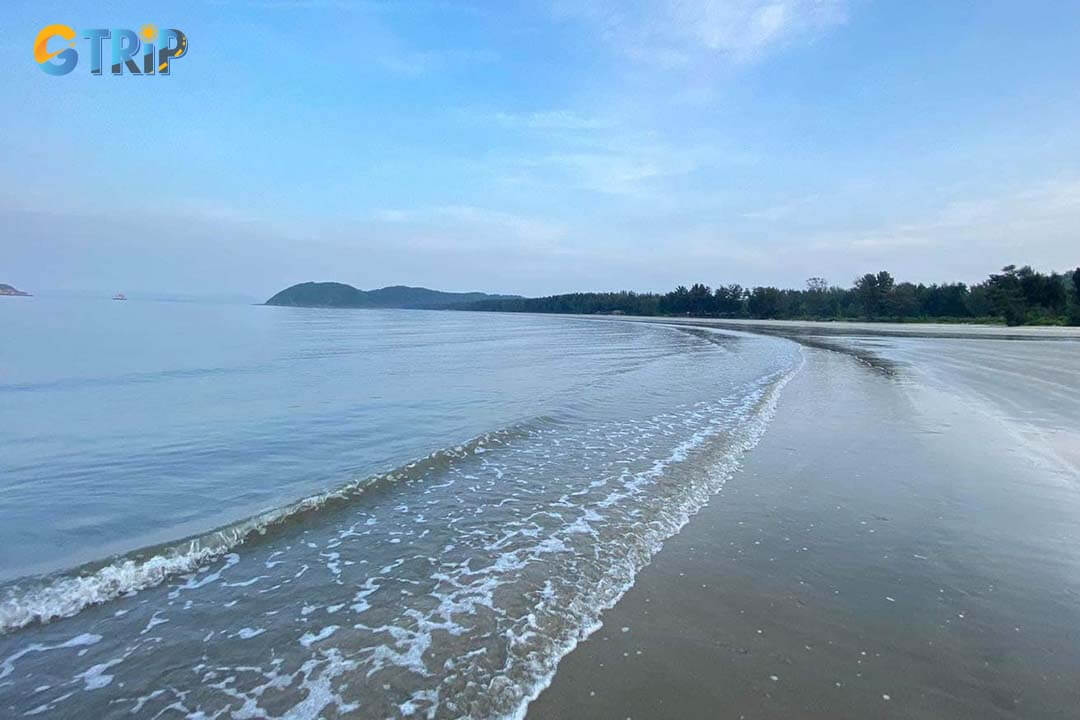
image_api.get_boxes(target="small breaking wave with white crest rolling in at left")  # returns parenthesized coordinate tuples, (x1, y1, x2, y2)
(0, 419, 531, 634)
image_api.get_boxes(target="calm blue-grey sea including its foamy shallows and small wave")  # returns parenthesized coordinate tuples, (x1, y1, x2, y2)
(0, 298, 802, 718)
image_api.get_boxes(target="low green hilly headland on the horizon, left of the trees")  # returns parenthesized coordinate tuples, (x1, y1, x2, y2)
(266, 283, 521, 310)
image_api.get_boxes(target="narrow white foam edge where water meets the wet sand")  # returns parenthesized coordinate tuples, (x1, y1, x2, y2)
(500, 345, 806, 720)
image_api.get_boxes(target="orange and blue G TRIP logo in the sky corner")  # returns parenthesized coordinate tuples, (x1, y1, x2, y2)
(33, 24, 188, 76)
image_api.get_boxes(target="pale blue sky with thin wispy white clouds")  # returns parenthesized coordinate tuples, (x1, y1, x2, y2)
(0, 0, 1080, 299)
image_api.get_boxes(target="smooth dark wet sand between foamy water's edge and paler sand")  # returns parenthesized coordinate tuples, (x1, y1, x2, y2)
(528, 343, 1080, 720)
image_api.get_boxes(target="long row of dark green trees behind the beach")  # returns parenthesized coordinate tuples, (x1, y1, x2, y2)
(463, 266, 1080, 325)
